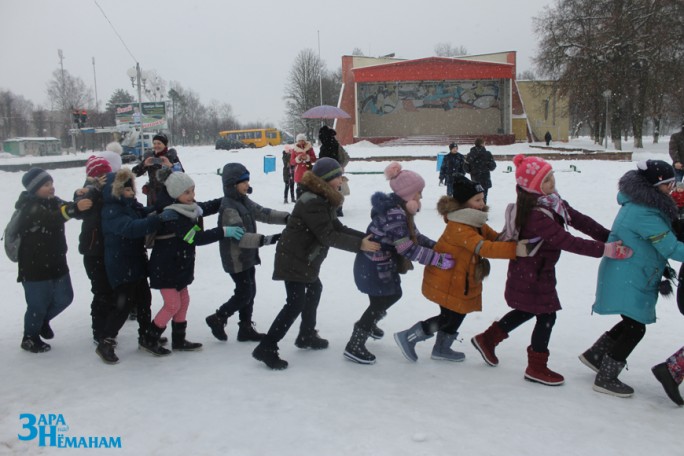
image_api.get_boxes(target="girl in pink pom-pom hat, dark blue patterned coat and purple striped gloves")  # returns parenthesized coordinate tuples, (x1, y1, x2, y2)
(344, 162, 454, 364)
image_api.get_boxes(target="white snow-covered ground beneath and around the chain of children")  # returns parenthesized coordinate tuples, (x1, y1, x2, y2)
(0, 138, 684, 456)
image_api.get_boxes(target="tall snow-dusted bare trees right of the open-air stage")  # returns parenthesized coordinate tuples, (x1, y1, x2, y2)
(535, 0, 684, 149)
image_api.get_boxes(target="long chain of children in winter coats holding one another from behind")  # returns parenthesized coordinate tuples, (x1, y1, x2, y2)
(10, 135, 684, 405)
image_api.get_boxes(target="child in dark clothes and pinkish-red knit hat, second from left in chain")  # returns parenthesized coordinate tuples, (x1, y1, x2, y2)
(74, 155, 114, 344)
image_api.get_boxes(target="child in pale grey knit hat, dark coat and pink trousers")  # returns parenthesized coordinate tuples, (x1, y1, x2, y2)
(149, 169, 238, 351)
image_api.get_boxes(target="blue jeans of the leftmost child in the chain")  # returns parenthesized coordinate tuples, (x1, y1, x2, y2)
(21, 273, 74, 336)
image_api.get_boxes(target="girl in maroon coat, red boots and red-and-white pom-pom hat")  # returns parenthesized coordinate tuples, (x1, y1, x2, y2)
(471, 154, 631, 386)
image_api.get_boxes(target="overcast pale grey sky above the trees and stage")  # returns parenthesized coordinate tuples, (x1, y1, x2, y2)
(0, 0, 554, 125)
